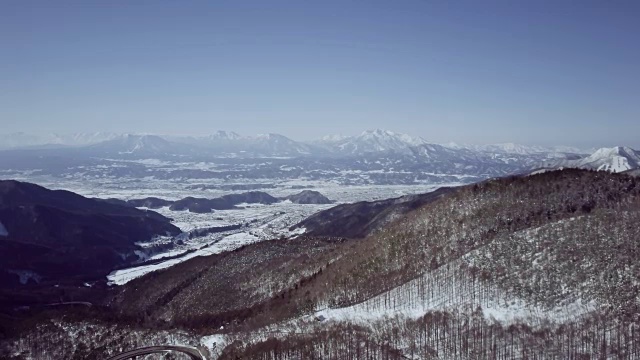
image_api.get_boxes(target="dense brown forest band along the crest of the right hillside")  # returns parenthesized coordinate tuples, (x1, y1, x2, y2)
(302, 170, 640, 312)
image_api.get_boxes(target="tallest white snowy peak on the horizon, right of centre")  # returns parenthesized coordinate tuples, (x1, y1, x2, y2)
(314, 129, 428, 155)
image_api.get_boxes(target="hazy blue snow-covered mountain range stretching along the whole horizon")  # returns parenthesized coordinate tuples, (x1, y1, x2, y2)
(0, 129, 640, 185)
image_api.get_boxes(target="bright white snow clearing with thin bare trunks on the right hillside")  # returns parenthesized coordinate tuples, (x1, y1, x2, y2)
(316, 260, 597, 325)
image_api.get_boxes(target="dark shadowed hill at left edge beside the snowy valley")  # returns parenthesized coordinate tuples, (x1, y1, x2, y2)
(0, 180, 180, 294)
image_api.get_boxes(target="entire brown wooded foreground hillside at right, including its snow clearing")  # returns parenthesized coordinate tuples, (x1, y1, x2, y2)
(5, 169, 640, 359)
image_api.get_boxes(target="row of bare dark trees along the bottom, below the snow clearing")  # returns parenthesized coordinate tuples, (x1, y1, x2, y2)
(220, 311, 640, 360)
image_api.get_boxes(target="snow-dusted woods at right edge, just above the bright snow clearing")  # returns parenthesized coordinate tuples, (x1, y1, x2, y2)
(470, 209, 640, 321)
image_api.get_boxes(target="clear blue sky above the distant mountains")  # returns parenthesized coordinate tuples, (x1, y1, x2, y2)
(0, 0, 640, 147)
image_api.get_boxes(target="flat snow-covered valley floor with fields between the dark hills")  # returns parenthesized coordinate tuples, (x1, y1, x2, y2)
(5, 174, 462, 285)
